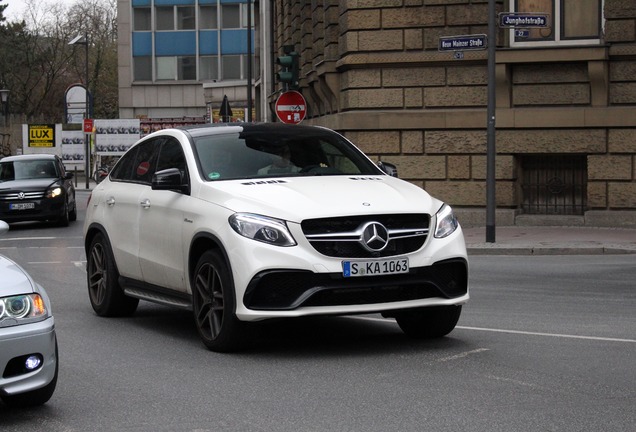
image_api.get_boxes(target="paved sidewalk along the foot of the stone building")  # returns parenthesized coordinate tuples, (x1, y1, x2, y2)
(464, 226, 636, 255)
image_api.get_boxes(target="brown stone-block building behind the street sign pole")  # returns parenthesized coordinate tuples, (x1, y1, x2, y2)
(270, 0, 636, 226)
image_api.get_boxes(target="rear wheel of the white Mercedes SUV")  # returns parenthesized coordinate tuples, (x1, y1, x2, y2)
(86, 234, 139, 316)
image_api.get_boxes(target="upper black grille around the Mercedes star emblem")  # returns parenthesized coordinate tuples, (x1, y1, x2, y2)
(301, 214, 431, 258)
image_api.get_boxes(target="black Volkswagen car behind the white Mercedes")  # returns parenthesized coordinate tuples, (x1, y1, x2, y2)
(0, 154, 77, 226)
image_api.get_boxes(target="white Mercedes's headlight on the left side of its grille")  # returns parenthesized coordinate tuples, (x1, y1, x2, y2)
(229, 213, 296, 246)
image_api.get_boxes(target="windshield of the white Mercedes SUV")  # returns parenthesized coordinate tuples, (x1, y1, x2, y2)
(194, 128, 382, 180)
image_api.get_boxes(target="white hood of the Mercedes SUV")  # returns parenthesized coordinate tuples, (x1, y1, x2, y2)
(200, 175, 442, 222)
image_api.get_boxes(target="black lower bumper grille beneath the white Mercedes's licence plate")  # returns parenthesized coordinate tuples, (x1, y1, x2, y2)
(243, 259, 468, 310)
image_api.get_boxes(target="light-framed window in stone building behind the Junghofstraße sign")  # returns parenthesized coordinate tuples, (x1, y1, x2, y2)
(510, 0, 603, 46)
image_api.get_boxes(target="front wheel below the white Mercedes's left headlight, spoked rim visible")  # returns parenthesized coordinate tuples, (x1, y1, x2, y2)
(192, 251, 246, 352)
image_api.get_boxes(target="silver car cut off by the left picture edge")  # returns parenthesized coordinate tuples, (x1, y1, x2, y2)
(0, 221, 58, 406)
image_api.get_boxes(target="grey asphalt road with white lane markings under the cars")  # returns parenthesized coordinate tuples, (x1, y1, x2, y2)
(0, 193, 636, 432)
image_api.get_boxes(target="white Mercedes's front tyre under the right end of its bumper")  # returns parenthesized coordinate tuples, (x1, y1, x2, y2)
(395, 306, 462, 339)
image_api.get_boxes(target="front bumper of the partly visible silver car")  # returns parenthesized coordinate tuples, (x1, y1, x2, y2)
(0, 317, 57, 395)
